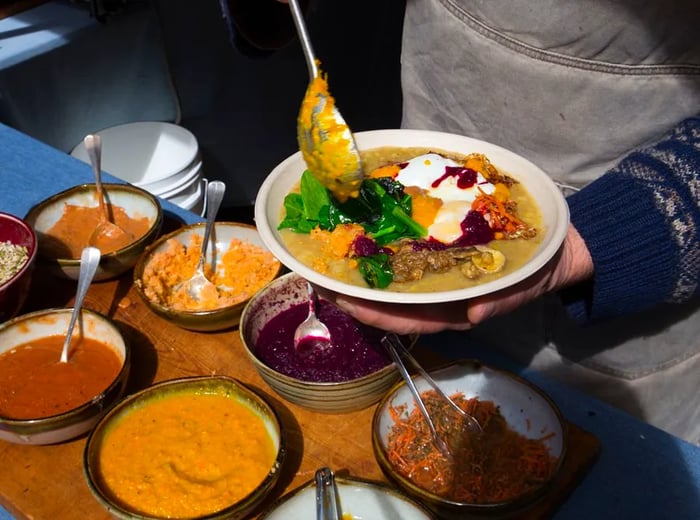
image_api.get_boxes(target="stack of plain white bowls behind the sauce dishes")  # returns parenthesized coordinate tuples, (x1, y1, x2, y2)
(71, 121, 207, 215)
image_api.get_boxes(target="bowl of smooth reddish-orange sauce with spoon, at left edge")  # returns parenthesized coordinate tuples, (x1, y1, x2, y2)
(0, 308, 130, 444)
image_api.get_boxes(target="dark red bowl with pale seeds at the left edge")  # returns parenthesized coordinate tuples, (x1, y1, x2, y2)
(0, 212, 37, 323)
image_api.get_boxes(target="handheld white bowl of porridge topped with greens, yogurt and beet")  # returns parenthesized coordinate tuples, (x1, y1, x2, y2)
(255, 130, 569, 303)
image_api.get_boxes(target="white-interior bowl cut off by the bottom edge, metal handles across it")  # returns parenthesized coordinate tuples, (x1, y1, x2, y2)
(258, 475, 433, 520)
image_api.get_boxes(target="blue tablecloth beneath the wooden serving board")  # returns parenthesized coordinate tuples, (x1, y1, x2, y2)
(0, 124, 700, 520)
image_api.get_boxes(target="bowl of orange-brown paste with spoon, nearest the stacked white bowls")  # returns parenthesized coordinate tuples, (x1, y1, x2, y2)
(25, 183, 163, 281)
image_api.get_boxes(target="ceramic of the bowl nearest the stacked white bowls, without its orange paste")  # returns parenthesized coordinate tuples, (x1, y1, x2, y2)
(25, 184, 163, 281)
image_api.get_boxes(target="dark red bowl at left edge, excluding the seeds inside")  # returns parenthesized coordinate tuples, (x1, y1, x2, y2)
(0, 212, 37, 323)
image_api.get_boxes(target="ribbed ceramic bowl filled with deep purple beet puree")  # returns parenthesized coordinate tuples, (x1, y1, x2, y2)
(239, 273, 417, 413)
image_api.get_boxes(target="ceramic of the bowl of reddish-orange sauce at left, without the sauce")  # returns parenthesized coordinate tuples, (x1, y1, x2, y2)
(0, 308, 131, 444)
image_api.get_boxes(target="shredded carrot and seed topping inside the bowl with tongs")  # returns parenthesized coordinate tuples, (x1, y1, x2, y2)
(387, 390, 558, 504)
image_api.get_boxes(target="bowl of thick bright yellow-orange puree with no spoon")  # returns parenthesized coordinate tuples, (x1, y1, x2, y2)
(83, 376, 285, 520)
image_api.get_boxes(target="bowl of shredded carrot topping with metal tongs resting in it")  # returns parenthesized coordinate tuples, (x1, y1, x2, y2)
(372, 360, 567, 518)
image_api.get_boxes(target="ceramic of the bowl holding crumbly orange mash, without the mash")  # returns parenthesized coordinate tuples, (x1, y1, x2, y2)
(134, 222, 282, 332)
